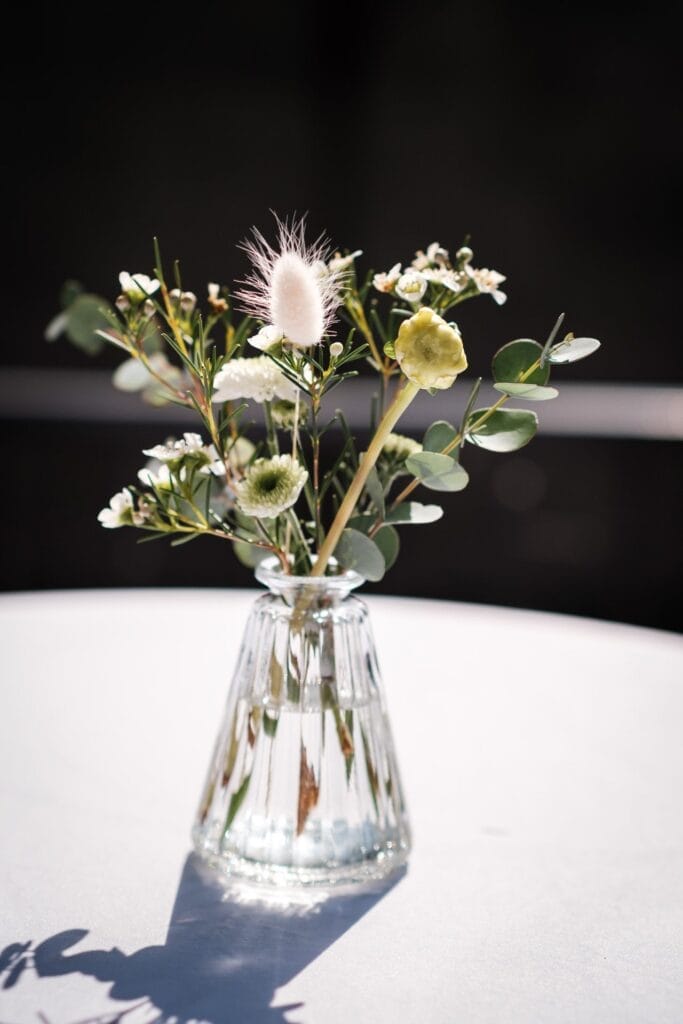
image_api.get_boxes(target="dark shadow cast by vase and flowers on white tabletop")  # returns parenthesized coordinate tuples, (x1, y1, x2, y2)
(0, 855, 401, 1024)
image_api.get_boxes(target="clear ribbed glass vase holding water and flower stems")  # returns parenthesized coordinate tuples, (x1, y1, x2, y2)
(193, 559, 410, 886)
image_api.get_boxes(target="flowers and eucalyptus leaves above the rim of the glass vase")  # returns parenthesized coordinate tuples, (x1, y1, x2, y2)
(47, 220, 599, 581)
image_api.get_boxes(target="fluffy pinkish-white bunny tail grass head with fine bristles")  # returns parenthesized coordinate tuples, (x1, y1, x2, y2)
(237, 218, 345, 348)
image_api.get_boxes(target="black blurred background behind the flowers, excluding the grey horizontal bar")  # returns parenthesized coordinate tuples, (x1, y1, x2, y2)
(0, 3, 681, 628)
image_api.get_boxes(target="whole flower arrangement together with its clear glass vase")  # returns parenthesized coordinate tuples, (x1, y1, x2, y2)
(48, 220, 599, 884)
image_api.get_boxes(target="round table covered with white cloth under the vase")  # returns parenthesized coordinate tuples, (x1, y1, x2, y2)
(0, 590, 683, 1024)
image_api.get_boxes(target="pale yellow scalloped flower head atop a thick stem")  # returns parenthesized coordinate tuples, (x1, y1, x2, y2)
(394, 306, 467, 389)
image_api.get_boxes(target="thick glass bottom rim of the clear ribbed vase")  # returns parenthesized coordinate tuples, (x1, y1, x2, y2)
(189, 839, 409, 890)
